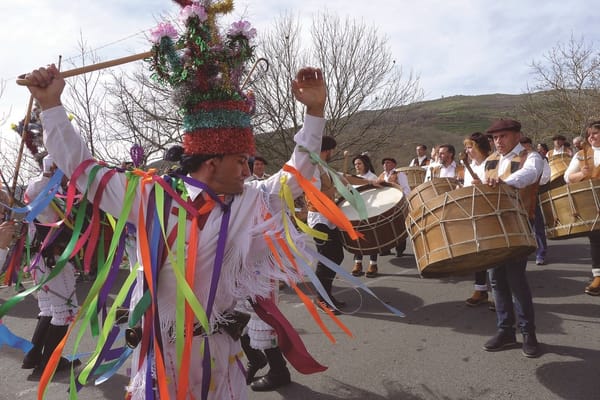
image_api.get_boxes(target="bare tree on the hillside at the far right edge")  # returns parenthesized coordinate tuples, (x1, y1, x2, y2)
(523, 36, 600, 140)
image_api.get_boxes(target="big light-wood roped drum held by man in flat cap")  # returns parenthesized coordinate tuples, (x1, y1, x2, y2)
(406, 184, 536, 277)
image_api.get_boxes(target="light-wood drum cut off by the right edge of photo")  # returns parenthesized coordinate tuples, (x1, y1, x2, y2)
(539, 179, 600, 239)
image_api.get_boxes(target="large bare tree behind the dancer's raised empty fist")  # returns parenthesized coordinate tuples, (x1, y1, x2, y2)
(253, 13, 422, 166)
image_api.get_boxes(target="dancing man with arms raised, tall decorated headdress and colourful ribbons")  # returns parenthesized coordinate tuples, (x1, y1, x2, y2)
(27, 2, 326, 400)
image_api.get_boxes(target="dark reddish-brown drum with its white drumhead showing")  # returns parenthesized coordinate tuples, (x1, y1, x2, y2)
(338, 184, 408, 255)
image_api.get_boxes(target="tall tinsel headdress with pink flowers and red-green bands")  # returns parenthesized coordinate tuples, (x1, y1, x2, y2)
(151, 0, 256, 154)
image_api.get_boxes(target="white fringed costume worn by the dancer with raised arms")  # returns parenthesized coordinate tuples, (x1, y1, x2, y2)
(42, 106, 325, 400)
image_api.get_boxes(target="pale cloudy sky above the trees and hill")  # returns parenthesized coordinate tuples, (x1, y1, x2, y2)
(0, 0, 600, 135)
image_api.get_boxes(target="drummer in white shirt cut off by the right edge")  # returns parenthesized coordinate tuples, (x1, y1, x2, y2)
(564, 120, 600, 296)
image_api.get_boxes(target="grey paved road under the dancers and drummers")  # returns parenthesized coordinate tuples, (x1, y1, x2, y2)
(0, 239, 600, 400)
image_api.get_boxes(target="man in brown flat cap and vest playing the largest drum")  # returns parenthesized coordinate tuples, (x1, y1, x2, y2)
(483, 119, 544, 357)
